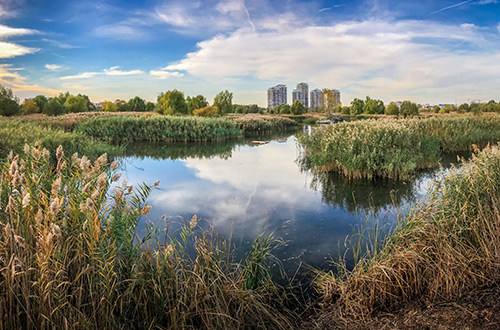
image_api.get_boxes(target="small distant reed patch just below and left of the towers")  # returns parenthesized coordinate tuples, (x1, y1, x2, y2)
(228, 114, 299, 136)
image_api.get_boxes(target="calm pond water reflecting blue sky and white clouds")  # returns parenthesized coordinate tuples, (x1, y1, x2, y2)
(115, 136, 462, 274)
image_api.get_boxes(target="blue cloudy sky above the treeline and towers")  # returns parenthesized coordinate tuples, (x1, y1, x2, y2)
(0, 0, 500, 106)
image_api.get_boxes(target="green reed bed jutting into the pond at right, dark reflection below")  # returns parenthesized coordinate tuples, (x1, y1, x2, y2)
(299, 115, 500, 179)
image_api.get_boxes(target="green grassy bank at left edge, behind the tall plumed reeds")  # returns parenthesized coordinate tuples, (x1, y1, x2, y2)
(0, 118, 121, 158)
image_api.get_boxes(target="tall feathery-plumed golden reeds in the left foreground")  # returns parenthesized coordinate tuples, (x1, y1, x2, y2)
(0, 144, 291, 329)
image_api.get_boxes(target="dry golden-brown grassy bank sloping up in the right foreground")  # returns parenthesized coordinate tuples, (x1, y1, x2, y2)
(318, 147, 500, 324)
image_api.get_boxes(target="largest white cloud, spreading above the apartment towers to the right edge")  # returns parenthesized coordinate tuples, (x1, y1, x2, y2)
(159, 20, 500, 102)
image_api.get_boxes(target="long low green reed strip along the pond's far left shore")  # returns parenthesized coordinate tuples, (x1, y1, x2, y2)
(76, 116, 241, 142)
